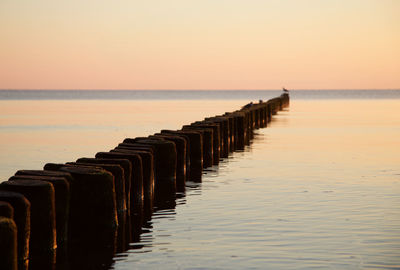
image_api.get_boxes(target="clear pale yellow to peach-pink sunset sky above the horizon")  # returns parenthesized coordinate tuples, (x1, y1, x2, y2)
(0, 0, 400, 89)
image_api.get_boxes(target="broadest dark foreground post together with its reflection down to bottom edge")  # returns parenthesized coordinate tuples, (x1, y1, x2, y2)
(44, 163, 118, 269)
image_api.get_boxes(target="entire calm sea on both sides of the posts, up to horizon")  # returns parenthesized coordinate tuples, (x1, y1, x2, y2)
(0, 90, 400, 270)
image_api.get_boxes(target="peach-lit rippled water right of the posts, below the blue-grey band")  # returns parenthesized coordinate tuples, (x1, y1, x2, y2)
(113, 101, 400, 269)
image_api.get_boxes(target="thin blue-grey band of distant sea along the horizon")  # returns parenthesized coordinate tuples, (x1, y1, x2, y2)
(0, 89, 400, 101)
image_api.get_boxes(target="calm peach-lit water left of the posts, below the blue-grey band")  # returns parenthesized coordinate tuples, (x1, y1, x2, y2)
(0, 100, 248, 182)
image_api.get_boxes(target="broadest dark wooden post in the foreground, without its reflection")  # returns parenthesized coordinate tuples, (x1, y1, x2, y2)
(44, 163, 118, 245)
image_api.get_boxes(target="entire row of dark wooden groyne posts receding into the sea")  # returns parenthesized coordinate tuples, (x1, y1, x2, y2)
(0, 93, 289, 270)
